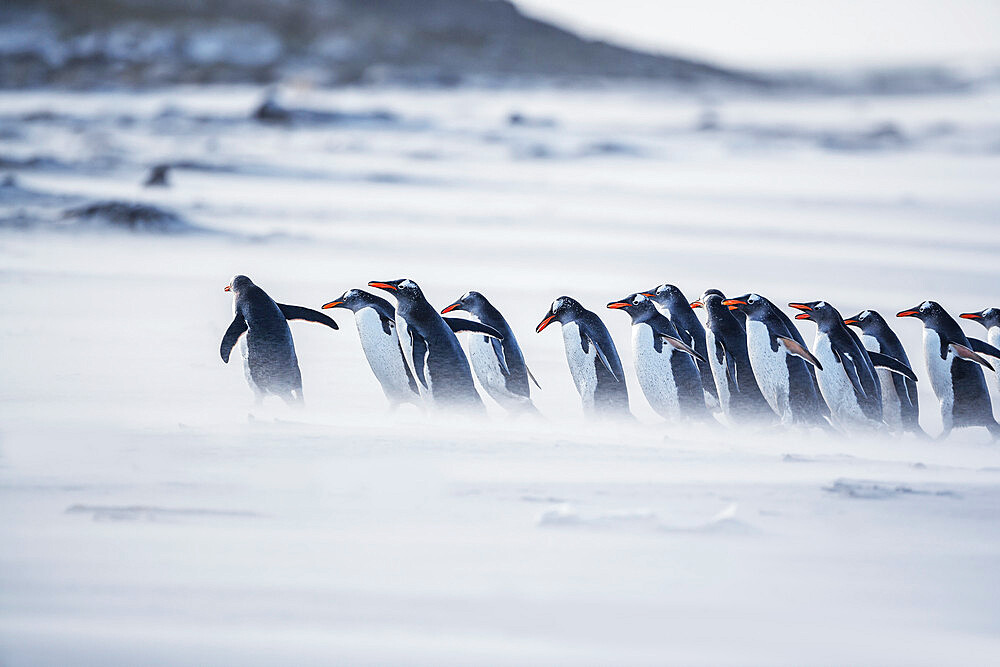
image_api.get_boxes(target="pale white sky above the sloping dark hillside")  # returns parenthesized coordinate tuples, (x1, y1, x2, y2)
(514, 0, 1000, 67)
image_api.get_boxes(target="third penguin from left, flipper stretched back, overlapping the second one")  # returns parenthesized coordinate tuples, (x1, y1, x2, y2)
(368, 278, 503, 412)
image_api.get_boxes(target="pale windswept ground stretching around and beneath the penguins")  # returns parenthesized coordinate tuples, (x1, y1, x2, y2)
(0, 88, 1000, 666)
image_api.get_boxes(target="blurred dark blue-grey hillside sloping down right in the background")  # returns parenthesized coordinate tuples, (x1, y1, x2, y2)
(0, 0, 767, 88)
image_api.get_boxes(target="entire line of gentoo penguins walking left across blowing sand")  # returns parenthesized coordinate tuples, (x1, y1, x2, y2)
(221, 275, 1000, 439)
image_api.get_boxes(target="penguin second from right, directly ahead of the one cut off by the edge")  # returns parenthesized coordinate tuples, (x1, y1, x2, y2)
(896, 301, 1000, 438)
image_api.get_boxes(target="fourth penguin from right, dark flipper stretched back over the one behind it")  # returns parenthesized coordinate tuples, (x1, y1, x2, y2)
(788, 301, 917, 431)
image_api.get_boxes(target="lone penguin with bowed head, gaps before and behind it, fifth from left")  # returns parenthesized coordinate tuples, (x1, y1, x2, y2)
(535, 296, 631, 417)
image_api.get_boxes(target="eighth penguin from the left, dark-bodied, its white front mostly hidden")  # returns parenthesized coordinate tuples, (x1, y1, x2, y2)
(691, 290, 773, 422)
